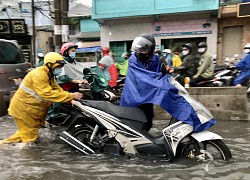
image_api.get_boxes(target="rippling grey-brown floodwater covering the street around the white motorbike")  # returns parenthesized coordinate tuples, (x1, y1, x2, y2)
(0, 116, 250, 180)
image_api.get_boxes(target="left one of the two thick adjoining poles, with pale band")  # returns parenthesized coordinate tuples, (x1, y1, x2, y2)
(54, 0, 62, 52)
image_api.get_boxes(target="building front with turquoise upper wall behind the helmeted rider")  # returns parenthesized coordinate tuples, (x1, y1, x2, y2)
(92, 0, 219, 61)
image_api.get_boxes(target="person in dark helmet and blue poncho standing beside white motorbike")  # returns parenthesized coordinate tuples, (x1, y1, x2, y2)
(120, 34, 215, 132)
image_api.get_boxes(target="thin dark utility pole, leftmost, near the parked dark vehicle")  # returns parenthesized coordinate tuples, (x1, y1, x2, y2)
(31, 0, 36, 66)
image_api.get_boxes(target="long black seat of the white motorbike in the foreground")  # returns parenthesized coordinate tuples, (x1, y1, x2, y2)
(84, 100, 147, 123)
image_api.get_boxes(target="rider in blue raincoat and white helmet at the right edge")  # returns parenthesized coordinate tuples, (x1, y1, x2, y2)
(233, 43, 250, 87)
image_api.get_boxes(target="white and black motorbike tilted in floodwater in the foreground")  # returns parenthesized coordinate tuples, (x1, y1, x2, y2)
(60, 77, 232, 162)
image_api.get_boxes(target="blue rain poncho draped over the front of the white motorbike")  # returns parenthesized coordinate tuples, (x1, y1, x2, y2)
(120, 55, 215, 132)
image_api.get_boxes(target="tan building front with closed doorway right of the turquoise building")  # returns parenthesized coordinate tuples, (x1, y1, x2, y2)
(217, 0, 250, 64)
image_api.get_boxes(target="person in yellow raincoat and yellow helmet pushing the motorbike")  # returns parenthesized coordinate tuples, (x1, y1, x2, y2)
(0, 52, 83, 144)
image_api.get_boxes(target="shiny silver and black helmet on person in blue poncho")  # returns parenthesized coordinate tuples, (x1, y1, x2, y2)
(131, 34, 155, 56)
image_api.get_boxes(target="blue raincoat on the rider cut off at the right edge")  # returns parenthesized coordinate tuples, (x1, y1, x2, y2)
(233, 54, 250, 85)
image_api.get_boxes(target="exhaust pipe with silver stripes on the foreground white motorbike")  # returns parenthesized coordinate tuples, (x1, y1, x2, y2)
(60, 131, 95, 155)
